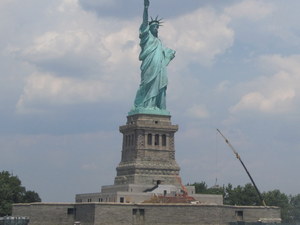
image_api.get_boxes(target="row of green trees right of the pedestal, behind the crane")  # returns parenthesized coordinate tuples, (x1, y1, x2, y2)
(189, 182, 300, 224)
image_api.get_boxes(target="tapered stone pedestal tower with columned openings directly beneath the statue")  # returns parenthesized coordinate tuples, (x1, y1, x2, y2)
(114, 114, 180, 187)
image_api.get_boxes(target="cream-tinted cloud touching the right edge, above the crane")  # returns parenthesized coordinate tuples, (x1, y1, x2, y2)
(230, 55, 300, 114)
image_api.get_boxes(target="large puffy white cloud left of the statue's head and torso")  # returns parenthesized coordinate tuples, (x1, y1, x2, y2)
(12, 0, 138, 76)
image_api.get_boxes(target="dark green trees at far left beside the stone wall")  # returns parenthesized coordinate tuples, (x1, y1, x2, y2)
(0, 171, 41, 216)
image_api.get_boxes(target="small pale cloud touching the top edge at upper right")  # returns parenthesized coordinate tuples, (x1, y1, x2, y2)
(225, 0, 274, 21)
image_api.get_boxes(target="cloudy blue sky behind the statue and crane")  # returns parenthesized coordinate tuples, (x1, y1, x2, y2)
(0, 0, 300, 202)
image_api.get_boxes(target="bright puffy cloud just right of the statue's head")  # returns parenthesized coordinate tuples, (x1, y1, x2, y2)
(162, 8, 234, 65)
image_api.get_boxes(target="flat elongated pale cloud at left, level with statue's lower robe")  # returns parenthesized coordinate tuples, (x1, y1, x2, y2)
(17, 73, 115, 113)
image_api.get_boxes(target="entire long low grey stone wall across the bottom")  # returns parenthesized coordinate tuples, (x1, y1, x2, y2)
(13, 203, 280, 225)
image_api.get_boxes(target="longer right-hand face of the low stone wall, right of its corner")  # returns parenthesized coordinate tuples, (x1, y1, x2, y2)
(90, 204, 280, 225)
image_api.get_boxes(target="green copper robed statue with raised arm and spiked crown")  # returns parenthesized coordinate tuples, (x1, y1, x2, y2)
(129, 0, 175, 115)
